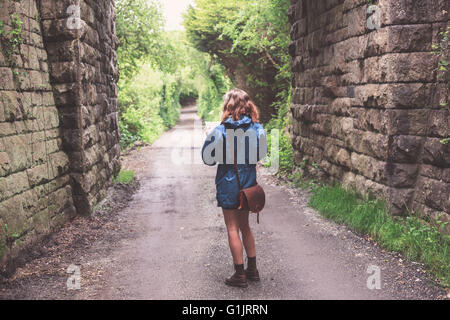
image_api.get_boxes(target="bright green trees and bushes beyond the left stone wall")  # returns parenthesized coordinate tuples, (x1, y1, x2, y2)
(116, 0, 230, 148)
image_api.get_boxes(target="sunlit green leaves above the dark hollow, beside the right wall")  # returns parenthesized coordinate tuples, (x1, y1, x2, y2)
(185, 0, 290, 74)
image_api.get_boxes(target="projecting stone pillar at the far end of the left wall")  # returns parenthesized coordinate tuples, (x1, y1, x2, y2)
(40, 0, 120, 214)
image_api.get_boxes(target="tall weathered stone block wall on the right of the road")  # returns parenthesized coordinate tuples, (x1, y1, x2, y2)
(289, 0, 450, 219)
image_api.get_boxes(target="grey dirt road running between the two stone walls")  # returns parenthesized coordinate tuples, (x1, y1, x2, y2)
(0, 106, 444, 299)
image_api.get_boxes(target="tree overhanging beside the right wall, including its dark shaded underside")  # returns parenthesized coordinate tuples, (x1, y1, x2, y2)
(185, 0, 291, 118)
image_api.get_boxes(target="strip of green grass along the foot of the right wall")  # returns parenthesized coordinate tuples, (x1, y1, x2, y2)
(309, 185, 450, 286)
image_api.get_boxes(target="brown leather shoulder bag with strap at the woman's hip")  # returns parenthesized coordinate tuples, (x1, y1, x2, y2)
(234, 155, 266, 223)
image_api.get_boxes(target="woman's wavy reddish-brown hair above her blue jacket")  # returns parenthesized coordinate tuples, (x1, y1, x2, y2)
(222, 89, 259, 123)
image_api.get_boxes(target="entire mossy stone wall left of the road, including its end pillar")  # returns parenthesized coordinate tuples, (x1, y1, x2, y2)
(0, 0, 120, 273)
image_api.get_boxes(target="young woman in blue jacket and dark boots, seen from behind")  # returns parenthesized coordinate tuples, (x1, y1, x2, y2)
(202, 89, 267, 287)
